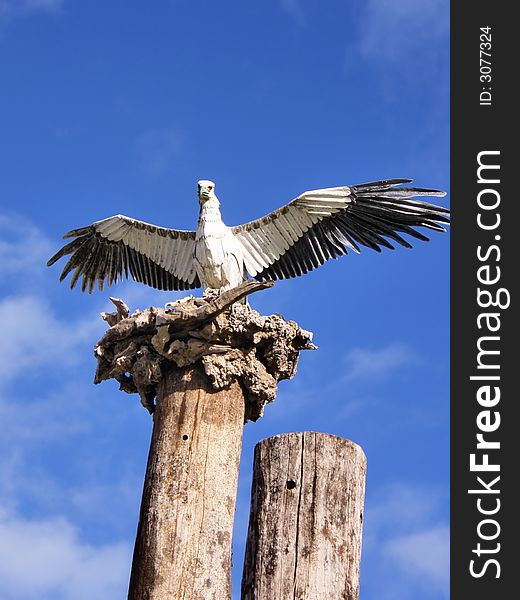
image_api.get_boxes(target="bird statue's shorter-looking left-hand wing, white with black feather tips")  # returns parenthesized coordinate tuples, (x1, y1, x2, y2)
(47, 215, 200, 293)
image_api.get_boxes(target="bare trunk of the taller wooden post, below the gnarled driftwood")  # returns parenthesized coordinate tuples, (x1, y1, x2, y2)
(128, 365, 244, 600)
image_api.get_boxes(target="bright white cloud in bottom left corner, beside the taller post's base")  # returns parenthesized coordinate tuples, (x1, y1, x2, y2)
(0, 514, 131, 600)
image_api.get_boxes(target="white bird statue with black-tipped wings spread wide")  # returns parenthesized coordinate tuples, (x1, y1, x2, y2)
(47, 179, 449, 292)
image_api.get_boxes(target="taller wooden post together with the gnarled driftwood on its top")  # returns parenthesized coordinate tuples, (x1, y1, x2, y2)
(94, 281, 315, 600)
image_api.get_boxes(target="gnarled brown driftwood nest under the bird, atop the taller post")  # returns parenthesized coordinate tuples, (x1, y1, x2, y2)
(94, 281, 315, 421)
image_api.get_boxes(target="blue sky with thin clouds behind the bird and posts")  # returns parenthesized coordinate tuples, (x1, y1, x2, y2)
(0, 0, 449, 600)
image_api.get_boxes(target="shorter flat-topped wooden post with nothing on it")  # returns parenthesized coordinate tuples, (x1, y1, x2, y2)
(242, 432, 366, 600)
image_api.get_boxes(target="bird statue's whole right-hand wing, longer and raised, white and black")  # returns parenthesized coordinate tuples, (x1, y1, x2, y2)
(232, 179, 449, 280)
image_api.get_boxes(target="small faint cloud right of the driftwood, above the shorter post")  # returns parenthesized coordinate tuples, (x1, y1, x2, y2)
(343, 343, 418, 381)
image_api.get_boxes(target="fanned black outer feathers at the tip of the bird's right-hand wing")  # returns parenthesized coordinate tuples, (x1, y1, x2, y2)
(343, 179, 450, 252)
